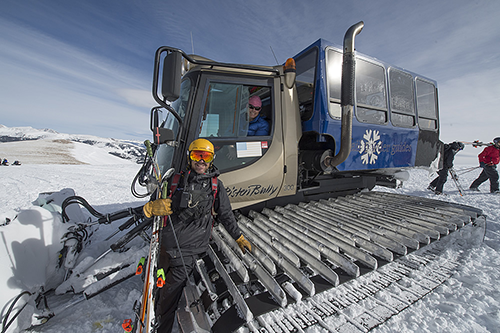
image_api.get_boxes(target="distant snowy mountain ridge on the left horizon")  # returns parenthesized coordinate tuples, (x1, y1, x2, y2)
(0, 125, 146, 163)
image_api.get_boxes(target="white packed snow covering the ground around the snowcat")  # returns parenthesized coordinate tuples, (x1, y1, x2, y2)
(0, 138, 500, 333)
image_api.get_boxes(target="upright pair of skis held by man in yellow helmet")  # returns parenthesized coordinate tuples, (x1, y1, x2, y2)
(122, 140, 174, 333)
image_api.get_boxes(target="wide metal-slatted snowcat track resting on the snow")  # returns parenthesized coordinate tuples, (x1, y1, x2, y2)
(179, 192, 486, 333)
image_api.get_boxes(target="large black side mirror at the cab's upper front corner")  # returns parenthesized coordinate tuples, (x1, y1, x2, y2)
(161, 51, 182, 102)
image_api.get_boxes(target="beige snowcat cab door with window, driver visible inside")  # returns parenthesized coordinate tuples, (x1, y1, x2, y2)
(191, 75, 284, 209)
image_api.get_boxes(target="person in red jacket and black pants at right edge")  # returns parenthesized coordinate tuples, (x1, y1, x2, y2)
(469, 137, 500, 194)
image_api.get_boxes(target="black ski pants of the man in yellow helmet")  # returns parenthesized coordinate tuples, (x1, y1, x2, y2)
(155, 250, 197, 333)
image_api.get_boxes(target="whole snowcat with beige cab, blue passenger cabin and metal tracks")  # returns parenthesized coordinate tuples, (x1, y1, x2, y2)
(143, 22, 485, 332)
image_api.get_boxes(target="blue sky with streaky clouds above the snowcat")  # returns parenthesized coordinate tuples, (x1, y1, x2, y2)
(0, 0, 500, 163)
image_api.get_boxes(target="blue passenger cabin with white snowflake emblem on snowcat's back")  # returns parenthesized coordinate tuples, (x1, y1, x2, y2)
(294, 39, 441, 181)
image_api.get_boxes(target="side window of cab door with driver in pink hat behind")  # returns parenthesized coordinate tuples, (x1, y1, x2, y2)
(199, 81, 273, 171)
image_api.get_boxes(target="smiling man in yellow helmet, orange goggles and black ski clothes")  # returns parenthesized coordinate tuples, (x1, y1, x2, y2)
(143, 139, 252, 333)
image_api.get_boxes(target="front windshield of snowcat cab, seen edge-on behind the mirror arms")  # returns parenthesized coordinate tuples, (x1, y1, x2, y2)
(155, 78, 191, 175)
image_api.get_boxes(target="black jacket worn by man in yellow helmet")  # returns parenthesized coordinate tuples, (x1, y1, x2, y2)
(161, 167, 241, 258)
